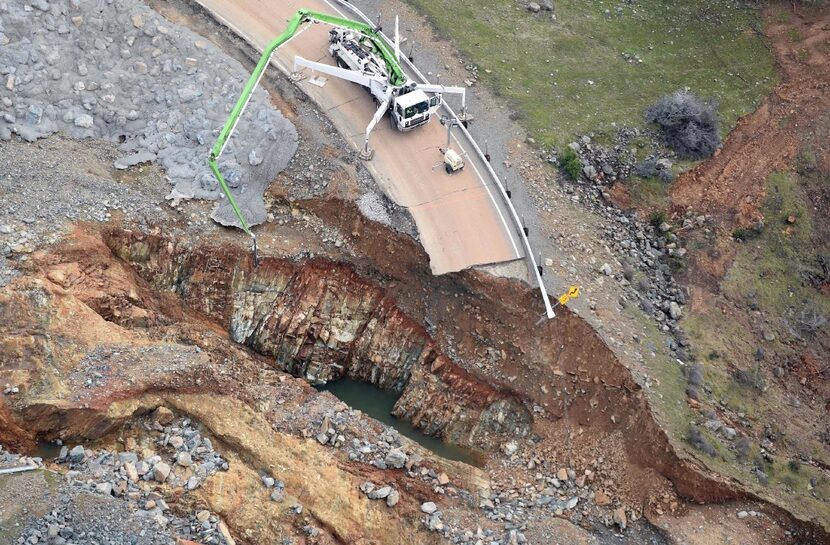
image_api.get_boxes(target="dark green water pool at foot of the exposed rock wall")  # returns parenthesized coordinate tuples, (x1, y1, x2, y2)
(318, 379, 484, 467)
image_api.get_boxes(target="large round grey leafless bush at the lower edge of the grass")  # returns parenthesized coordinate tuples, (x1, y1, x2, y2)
(646, 91, 721, 159)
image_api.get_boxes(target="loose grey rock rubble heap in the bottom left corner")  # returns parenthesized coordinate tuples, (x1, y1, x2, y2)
(10, 407, 234, 545)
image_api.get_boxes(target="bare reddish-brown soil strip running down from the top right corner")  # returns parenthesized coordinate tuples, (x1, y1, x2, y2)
(670, 3, 830, 286)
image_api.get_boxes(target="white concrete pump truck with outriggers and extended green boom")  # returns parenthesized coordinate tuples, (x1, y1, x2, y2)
(208, 10, 467, 264)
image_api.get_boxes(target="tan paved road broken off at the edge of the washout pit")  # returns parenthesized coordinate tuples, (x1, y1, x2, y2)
(199, 0, 523, 274)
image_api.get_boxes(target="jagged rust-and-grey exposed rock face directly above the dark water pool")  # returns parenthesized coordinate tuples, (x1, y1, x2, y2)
(106, 227, 531, 444)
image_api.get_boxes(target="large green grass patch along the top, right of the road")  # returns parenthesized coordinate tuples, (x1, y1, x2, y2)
(408, 0, 776, 146)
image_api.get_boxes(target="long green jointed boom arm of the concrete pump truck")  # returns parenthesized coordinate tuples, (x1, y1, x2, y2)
(208, 9, 407, 251)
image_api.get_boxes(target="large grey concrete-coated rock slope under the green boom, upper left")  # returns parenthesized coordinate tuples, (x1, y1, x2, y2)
(0, 0, 297, 225)
